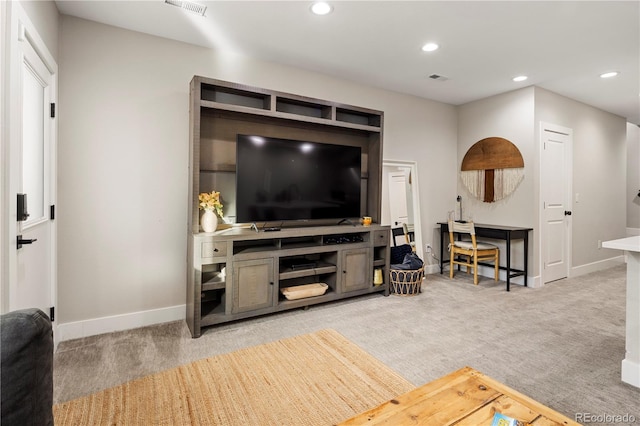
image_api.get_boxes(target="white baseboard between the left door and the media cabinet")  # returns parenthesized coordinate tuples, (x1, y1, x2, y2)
(54, 305, 186, 345)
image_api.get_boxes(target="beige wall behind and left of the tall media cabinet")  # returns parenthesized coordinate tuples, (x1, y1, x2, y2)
(53, 16, 456, 324)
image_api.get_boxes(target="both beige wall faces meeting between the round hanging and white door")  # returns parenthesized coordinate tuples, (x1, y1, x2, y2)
(457, 87, 627, 282)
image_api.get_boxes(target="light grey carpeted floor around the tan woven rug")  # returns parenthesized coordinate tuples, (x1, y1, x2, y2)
(54, 265, 640, 424)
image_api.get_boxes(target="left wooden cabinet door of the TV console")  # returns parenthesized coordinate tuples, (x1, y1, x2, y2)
(232, 259, 274, 313)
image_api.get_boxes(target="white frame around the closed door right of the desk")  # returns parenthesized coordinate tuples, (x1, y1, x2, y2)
(538, 121, 573, 286)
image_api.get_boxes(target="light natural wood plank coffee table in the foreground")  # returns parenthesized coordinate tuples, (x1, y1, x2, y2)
(340, 367, 579, 426)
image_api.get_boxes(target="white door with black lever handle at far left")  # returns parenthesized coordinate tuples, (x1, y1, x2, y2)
(3, 2, 57, 315)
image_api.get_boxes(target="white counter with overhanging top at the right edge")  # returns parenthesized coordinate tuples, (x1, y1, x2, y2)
(602, 235, 640, 388)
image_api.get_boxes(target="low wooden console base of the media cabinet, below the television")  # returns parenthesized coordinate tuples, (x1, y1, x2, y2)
(187, 225, 389, 337)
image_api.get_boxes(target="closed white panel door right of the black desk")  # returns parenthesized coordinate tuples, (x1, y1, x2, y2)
(540, 123, 572, 283)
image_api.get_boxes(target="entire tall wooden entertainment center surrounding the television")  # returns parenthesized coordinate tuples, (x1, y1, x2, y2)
(186, 76, 389, 337)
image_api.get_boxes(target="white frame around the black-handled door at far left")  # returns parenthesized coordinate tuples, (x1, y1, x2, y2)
(0, 2, 59, 320)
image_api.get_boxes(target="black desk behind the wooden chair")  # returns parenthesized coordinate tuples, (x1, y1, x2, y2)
(438, 222, 533, 291)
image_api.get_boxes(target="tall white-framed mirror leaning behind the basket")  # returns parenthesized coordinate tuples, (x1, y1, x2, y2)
(381, 160, 424, 259)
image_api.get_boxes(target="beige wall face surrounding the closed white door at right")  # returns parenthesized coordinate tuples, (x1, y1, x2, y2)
(536, 88, 627, 274)
